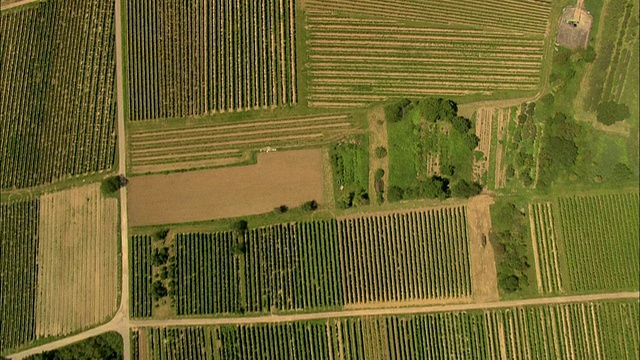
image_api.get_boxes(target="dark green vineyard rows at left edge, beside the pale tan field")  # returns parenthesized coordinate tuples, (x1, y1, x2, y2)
(0, 200, 39, 353)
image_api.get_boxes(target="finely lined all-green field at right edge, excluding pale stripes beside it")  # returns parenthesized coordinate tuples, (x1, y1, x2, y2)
(558, 192, 640, 291)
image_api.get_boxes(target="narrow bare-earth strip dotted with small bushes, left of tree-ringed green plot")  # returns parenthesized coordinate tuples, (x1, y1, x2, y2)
(367, 107, 389, 204)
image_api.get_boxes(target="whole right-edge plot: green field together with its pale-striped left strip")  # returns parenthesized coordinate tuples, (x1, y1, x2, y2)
(529, 192, 640, 293)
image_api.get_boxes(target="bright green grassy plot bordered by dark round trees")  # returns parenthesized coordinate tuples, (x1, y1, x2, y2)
(385, 98, 481, 201)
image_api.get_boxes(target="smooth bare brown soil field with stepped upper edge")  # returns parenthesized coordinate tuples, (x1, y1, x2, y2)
(128, 149, 324, 226)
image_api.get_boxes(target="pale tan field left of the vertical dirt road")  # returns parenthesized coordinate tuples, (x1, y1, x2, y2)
(36, 184, 119, 337)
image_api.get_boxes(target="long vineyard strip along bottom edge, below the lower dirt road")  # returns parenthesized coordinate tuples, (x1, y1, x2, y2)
(132, 300, 639, 359)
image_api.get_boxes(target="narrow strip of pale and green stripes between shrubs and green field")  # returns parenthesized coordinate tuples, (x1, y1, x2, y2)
(529, 202, 563, 293)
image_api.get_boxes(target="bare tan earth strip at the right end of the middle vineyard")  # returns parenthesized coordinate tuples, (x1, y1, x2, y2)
(467, 195, 499, 303)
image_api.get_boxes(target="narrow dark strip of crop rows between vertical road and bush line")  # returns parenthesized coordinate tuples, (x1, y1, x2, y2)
(130, 235, 153, 317)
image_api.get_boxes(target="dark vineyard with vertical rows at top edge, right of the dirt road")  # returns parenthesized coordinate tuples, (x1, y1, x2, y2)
(127, 0, 297, 120)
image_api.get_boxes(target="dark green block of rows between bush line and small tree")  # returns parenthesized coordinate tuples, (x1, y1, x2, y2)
(176, 232, 242, 315)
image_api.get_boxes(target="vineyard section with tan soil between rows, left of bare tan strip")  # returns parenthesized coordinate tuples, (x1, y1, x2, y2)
(338, 207, 471, 304)
